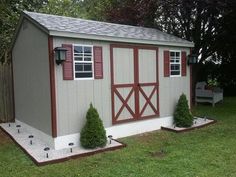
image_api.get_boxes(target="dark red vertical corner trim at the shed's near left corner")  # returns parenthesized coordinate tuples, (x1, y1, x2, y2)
(48, 36, 57, 138)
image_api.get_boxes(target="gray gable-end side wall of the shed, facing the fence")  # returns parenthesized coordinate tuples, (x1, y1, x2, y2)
(12, 20, 51, 135)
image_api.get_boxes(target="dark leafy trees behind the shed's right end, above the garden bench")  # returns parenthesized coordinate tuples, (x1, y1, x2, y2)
(104, 0, 236, 95)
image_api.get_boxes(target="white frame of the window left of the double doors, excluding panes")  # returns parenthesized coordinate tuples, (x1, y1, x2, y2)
(72, 44, 94, 80)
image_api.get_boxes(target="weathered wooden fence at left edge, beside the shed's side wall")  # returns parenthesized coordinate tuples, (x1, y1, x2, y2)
(0, 60, 14, 122)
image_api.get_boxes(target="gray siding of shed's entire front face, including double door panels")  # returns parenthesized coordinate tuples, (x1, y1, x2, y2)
(53, 38, 190, 136)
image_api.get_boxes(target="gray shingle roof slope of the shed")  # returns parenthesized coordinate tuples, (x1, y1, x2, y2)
(24, 11, 193, 45)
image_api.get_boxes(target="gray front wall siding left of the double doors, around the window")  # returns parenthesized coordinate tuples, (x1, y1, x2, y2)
(53, 38, 112, 136)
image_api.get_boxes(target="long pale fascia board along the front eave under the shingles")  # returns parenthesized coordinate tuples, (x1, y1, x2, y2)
(49, 31, 194, 47)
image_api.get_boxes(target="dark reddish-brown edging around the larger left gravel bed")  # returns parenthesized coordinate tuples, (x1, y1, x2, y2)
(0, 126, 127, 166)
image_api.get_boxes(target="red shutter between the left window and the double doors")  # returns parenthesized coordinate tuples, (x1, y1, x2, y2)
(93, 46, 103, 79)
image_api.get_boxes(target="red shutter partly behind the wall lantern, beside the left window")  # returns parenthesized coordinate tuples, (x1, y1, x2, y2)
(62, 44, 74, 80)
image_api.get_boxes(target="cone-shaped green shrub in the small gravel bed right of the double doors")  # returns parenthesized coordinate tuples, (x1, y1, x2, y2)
(174, 94, 193, 127)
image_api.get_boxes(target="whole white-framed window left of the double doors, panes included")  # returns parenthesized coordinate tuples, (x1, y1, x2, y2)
(73, 45, 93, 79)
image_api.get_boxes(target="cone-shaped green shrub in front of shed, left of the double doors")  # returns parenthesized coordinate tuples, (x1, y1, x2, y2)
(80, 104, 107, 149)
